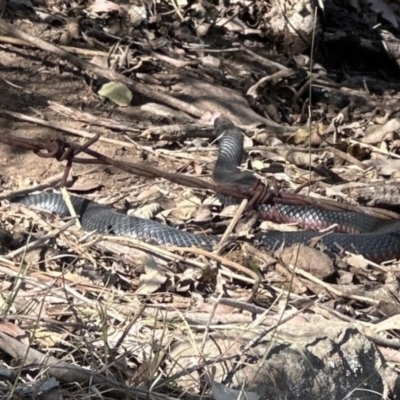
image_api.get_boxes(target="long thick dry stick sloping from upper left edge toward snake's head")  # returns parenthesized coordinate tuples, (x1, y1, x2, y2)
(0, 20, 202, 117)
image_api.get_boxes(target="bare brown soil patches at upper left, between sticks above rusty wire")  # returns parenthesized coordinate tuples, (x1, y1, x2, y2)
(0, 41, 152, 183)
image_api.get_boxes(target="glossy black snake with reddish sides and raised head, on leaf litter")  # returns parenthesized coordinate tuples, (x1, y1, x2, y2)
(12, 119, 400, 262)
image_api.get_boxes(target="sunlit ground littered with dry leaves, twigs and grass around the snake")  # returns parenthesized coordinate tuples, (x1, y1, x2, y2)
(0, 1, 400, 399)
